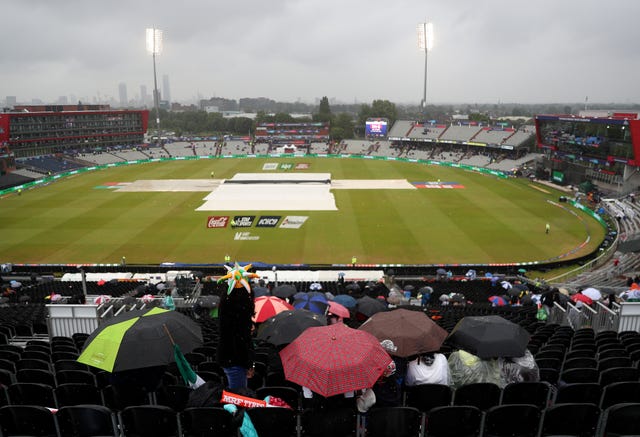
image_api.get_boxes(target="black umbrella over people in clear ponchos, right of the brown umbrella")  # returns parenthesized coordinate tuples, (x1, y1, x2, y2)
(447, 316, 529, 359)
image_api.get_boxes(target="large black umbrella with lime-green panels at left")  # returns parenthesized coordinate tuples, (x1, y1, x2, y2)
(78, 307, 202, 372)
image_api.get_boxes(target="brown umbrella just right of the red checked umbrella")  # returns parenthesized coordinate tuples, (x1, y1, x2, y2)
(358, 309, 447, 357)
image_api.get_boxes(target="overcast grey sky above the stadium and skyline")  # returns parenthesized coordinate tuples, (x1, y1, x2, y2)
(0, 0, 640, 104)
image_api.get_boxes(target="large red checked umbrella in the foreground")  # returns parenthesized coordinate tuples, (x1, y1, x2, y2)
(280, 323, 392, 397)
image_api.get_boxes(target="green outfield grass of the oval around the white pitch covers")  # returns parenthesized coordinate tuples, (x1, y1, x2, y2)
(0, 158, 605, 264)
